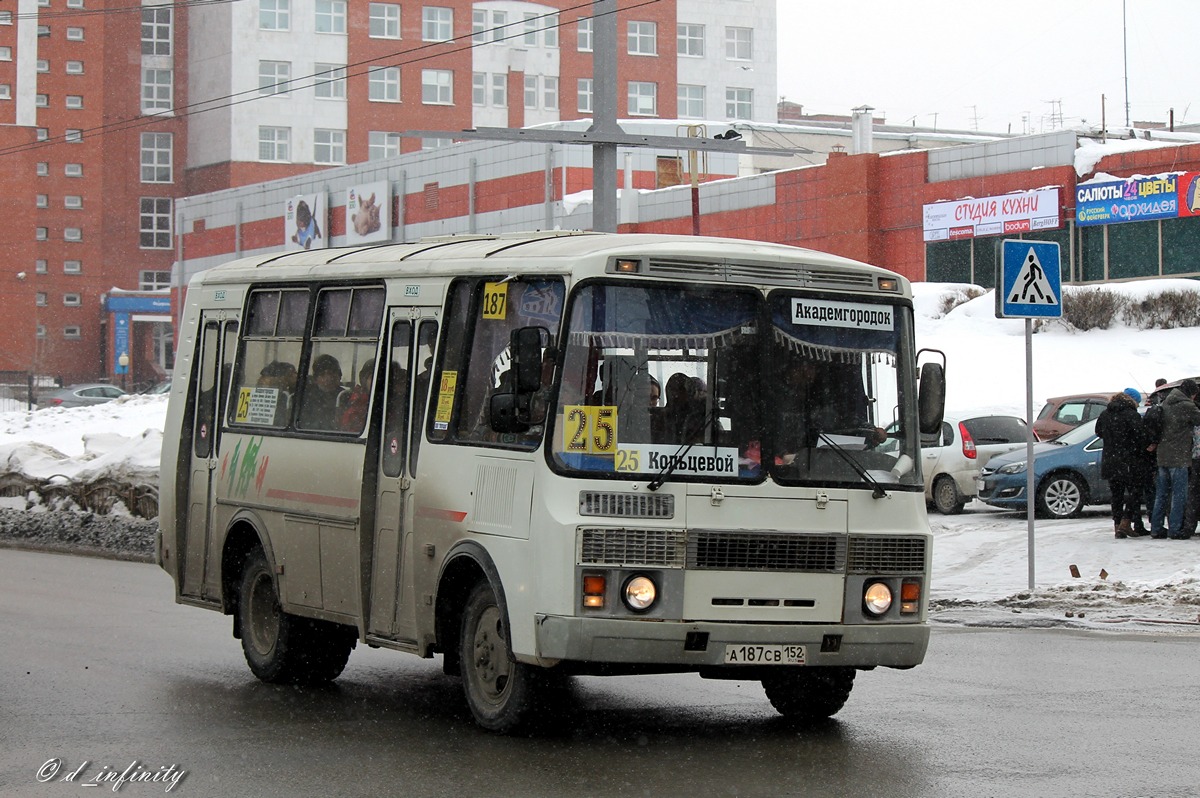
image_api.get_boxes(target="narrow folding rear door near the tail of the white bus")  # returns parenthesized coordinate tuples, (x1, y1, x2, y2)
(179, 311, 238, 599)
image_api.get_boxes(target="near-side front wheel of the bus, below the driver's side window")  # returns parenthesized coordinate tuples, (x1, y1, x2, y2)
(458, 582, 538, 732)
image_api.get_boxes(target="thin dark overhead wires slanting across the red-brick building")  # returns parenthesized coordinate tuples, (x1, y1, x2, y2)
(0, 0, 661, 157)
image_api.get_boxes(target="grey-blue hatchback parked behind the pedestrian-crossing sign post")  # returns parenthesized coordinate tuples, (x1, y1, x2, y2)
(979, 419, 1111, 518)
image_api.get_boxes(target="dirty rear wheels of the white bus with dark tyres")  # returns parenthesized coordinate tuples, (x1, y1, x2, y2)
(238, 550, 355, 684)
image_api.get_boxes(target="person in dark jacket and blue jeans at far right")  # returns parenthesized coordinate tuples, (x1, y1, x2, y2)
(1150, 379, 1200, 540)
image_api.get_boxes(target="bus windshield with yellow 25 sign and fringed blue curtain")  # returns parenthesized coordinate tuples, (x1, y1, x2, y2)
(550, 282, 919, 487)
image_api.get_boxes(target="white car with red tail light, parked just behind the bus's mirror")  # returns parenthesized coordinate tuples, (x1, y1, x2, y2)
(888, 415, 1028, 515)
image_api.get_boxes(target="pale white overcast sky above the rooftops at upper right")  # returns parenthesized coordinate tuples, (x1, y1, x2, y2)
(778, 0, 1200, 133)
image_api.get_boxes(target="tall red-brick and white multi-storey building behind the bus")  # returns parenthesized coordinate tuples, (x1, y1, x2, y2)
(0, 0, 775, 385)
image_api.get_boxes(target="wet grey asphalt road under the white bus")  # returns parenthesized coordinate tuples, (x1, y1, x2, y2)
(0, 550, 1200, 798)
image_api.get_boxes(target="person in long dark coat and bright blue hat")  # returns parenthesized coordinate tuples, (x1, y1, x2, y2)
(1096, 392, 1146, 539)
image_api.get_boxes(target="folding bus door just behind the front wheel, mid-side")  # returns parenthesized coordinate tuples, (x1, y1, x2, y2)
(367, 308, 437, 641)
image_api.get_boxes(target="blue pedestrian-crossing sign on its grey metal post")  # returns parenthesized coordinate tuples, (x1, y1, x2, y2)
(996, 239, 1062, 590)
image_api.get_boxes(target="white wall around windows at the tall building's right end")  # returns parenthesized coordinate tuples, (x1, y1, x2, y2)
(676, 0, 777, 122)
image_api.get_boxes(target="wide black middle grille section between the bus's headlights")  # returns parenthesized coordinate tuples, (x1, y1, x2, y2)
(688, 530, 846, 574)
